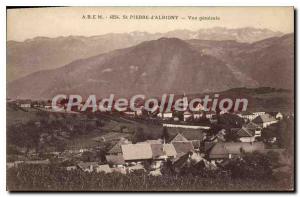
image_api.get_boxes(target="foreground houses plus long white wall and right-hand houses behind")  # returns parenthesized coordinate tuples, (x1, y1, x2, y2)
(59, 112, 283, 176)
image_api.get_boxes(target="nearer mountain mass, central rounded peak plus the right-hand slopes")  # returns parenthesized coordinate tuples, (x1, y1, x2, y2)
(7, 34, 294, 99)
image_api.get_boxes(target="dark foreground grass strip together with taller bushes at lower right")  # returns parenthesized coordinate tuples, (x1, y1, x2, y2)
(7, 154, 294, 191)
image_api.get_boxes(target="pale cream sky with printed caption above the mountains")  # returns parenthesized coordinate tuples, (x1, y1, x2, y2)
(7, 7, 294, 41)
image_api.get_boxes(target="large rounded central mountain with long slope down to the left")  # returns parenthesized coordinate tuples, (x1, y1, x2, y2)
(8, 38, 238, 98)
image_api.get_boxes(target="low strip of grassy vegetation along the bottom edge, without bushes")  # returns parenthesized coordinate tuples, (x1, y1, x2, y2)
(7, 168, 291, 191)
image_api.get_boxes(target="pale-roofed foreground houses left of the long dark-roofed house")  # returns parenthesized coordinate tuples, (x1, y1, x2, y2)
(71, 134, 195, 175)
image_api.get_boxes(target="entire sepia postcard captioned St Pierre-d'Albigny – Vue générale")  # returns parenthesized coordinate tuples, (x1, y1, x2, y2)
(6, 7, 295, 192)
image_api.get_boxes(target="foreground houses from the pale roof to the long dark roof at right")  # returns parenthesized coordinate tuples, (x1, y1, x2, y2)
(59, 133, 276, 176)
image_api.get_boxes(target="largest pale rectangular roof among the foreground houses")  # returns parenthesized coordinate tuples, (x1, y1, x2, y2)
(121, 144, 152, 161)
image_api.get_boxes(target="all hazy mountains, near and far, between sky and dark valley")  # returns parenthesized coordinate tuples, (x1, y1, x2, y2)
(7, 28, 294, 99)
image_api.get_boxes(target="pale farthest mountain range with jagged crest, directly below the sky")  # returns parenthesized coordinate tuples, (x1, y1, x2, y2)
(7, 27, 283, 81)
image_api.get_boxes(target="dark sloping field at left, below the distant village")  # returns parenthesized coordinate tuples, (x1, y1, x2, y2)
(7, 106, 162, 150)
